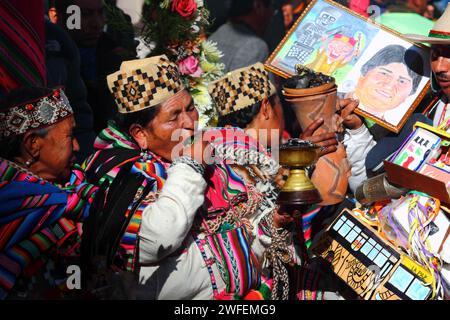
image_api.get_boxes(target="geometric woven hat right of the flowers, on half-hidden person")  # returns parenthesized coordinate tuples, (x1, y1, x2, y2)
(208, 62, 276, 116)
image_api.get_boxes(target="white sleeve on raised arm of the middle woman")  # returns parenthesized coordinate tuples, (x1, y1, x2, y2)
(139, 163, 206, 264)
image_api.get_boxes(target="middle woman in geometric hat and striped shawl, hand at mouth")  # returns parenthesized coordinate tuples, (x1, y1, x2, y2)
(83, 56, 288, 299)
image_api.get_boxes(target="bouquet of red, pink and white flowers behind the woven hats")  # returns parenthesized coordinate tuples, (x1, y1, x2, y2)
(142, 0, 224, 127)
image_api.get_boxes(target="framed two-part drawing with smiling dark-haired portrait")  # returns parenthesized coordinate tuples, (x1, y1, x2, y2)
(265, 0, 431, 132)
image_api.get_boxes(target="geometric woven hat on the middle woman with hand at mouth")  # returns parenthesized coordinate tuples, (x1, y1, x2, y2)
(107, 55, 184, 113)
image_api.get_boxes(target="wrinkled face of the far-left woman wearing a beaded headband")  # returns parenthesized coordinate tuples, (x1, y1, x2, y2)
(32, 116, 80, 183)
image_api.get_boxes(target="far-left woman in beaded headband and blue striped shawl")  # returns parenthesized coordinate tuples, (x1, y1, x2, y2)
(0, 87, 96, 299)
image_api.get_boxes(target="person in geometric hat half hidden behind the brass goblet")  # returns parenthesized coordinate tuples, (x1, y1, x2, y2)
(208, 63, 355, 300)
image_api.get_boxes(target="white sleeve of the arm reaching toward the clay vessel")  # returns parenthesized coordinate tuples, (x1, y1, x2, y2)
(343, 125, 377, 193)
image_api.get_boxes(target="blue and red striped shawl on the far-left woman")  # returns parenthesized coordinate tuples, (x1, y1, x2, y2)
(0, 159, 97, 298)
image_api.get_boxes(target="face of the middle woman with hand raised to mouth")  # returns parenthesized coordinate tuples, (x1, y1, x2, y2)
(145, 90, 198, 160)
